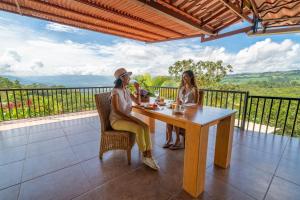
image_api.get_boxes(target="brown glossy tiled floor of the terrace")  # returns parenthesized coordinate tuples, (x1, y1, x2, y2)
(0, 113, 300, 200)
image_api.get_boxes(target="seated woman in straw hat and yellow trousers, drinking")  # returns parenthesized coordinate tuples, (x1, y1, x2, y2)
(109, 68, 159, 170)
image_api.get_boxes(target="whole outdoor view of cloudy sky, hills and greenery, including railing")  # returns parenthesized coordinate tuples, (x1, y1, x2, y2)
(0, 10, 300, 136)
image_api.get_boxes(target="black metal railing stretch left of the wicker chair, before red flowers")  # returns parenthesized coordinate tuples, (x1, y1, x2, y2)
(0, 87, 112, 121)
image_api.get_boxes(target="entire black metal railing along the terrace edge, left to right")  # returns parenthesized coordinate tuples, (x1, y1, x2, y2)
(0, 87, 300, 136)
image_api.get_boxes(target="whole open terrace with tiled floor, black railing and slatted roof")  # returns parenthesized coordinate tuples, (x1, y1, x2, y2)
(0, 0, 300, 200)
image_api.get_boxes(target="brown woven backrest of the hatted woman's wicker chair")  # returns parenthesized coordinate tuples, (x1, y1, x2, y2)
(95, 92, 112, 132)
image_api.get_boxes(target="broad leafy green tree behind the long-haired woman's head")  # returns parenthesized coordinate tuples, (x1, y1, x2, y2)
(169, 59, 232, 88)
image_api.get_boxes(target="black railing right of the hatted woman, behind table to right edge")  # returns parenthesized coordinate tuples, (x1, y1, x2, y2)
(153, 87, 300, 136)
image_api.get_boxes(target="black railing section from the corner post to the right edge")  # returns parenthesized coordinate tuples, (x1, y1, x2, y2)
(245, 96, 300, 136)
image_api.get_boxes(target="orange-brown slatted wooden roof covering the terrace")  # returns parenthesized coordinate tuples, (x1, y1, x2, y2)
(0, 0, 300, 42)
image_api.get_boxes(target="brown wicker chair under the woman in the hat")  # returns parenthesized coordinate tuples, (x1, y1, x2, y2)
(95, 92, 135, 165)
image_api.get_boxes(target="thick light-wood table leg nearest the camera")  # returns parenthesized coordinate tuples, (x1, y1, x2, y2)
(183, 124, 209, 197)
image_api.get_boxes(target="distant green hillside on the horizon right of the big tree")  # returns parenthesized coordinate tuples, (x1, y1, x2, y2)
(222, 70, 300, 84)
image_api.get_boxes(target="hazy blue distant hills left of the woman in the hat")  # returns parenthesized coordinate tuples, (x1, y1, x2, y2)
(3, 75, 114, 87)
